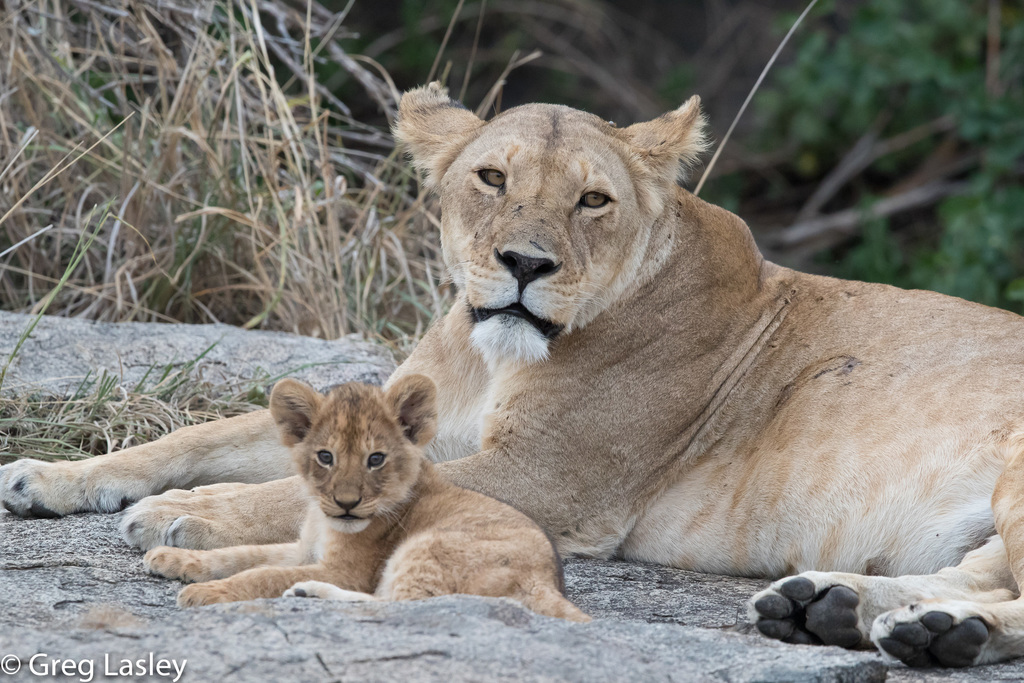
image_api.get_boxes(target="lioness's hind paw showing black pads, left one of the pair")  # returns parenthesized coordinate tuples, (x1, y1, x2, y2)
(748, 571, 868, 648)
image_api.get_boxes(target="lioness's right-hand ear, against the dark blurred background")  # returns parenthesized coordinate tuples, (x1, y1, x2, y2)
(623, 95, 708, 183)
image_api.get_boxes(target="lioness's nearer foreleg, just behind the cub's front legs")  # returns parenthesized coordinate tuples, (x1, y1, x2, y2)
(121, 476, 309, 550)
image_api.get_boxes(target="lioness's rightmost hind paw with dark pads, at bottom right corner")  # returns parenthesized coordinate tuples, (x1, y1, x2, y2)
(871, 600, 991, 667)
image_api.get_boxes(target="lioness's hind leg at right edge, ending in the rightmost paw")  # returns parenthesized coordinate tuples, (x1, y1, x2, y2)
(871, 444, 1024, 667)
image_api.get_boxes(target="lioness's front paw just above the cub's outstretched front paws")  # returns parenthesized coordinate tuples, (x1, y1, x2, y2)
(121, 488, 239, 550)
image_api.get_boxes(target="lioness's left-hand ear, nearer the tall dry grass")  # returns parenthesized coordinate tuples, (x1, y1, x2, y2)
(393, 81, 483, 188)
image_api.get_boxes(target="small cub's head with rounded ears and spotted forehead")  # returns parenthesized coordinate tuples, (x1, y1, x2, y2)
(270, 375, 436, 533)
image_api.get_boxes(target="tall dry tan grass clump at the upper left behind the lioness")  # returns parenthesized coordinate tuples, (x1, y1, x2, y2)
(0, 0, 446, 347)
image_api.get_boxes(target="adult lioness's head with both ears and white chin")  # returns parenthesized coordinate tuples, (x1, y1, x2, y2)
(396, 85, 701, 364)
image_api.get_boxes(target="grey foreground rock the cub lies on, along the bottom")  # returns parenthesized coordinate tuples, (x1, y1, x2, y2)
(0, 513, 886, 683)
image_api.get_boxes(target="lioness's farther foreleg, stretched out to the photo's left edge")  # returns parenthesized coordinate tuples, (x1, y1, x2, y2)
(0, 411, 292, 517)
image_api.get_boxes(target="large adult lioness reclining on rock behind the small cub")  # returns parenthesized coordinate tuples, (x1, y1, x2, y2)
(0, 85, 1024, 665)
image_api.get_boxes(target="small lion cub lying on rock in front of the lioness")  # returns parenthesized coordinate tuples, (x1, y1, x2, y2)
(143, 375, 590, 622)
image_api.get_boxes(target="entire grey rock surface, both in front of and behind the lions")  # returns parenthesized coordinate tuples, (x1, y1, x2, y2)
(0, 312, 1024, 683)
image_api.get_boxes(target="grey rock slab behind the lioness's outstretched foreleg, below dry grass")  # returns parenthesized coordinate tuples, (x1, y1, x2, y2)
(0, 311, 394, 395)
